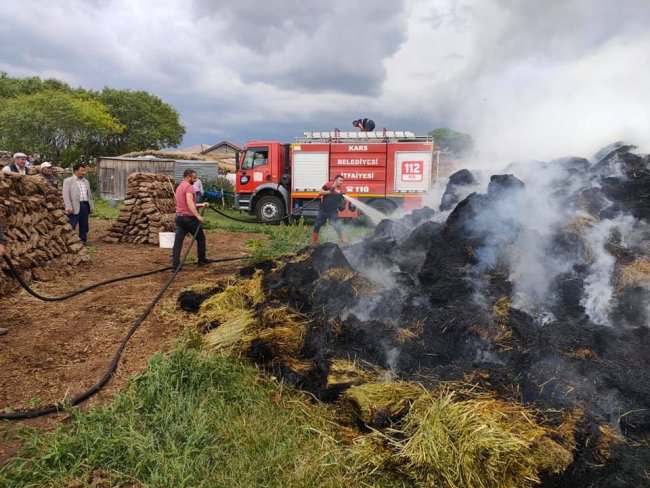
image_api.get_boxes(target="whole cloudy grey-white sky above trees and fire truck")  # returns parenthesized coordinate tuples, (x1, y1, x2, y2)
(0, 0, 650, 161)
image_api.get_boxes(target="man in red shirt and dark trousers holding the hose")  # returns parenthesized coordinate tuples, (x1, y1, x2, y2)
(172, 169, 214, 272)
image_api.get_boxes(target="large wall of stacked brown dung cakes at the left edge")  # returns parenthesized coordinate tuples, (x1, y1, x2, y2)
(0, 174, 89, 295)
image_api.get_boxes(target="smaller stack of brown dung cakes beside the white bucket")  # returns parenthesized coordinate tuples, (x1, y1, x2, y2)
(104, 173, 176, 248)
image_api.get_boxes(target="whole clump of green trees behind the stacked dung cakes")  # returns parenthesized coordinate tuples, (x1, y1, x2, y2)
(0, 72, 185, 162)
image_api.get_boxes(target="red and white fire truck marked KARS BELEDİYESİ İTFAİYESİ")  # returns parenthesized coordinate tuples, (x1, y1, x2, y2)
(235, 131, 434, 222)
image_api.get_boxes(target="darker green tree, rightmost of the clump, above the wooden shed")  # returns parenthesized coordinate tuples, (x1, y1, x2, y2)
(98, 88, 185, 156)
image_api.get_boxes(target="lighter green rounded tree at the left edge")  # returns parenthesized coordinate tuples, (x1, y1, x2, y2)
(0, 90, 124, 165)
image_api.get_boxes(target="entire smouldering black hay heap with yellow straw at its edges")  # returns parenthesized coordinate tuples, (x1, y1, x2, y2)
(180, 145, 650, 487)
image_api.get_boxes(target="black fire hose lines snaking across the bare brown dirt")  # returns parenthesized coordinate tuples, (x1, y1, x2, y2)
(0, 210, 245, 420)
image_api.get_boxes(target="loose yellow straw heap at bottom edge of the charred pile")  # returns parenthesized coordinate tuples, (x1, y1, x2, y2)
(354, 386, 573, 488)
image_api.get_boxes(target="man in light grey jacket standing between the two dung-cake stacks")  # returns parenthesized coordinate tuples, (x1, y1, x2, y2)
(63, 163, 95, 246)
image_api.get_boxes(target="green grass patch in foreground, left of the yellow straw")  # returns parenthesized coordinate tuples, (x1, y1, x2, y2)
(0, 339, 404, 487)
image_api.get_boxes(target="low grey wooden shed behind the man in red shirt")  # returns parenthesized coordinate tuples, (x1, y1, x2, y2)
(98, 156, 219, 200)
